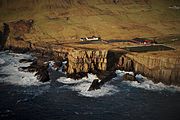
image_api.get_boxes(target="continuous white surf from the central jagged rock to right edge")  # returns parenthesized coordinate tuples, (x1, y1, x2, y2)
(57, 70, 180, 97)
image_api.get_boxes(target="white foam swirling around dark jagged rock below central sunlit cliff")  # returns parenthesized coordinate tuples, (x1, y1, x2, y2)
(58, 74, 118, 97)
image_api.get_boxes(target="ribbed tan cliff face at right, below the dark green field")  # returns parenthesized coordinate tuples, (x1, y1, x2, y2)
(117, 54, 180, 86)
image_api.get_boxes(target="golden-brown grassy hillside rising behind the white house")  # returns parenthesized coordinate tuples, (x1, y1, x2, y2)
(0, 0, 180, 42)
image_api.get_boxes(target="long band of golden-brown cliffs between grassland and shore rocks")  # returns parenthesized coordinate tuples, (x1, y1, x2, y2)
(1, 20, 180, 86)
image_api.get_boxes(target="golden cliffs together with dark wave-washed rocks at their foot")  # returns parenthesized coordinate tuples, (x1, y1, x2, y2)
(1, 20, 180, 90)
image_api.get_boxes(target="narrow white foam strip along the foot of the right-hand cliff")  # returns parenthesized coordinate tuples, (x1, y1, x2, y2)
(116, 70, 180, 92)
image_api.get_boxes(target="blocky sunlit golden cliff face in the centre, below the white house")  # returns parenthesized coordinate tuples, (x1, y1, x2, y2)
(67, 50, 107, 74)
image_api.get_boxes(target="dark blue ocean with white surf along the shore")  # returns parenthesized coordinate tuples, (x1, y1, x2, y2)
(0, 51, 180, 120)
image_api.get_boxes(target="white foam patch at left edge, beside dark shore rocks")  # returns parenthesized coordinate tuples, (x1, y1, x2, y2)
(0, 53, 43, 86)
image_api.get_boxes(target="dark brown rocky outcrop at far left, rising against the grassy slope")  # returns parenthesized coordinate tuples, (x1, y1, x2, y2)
(1, 19, 34, 51)
